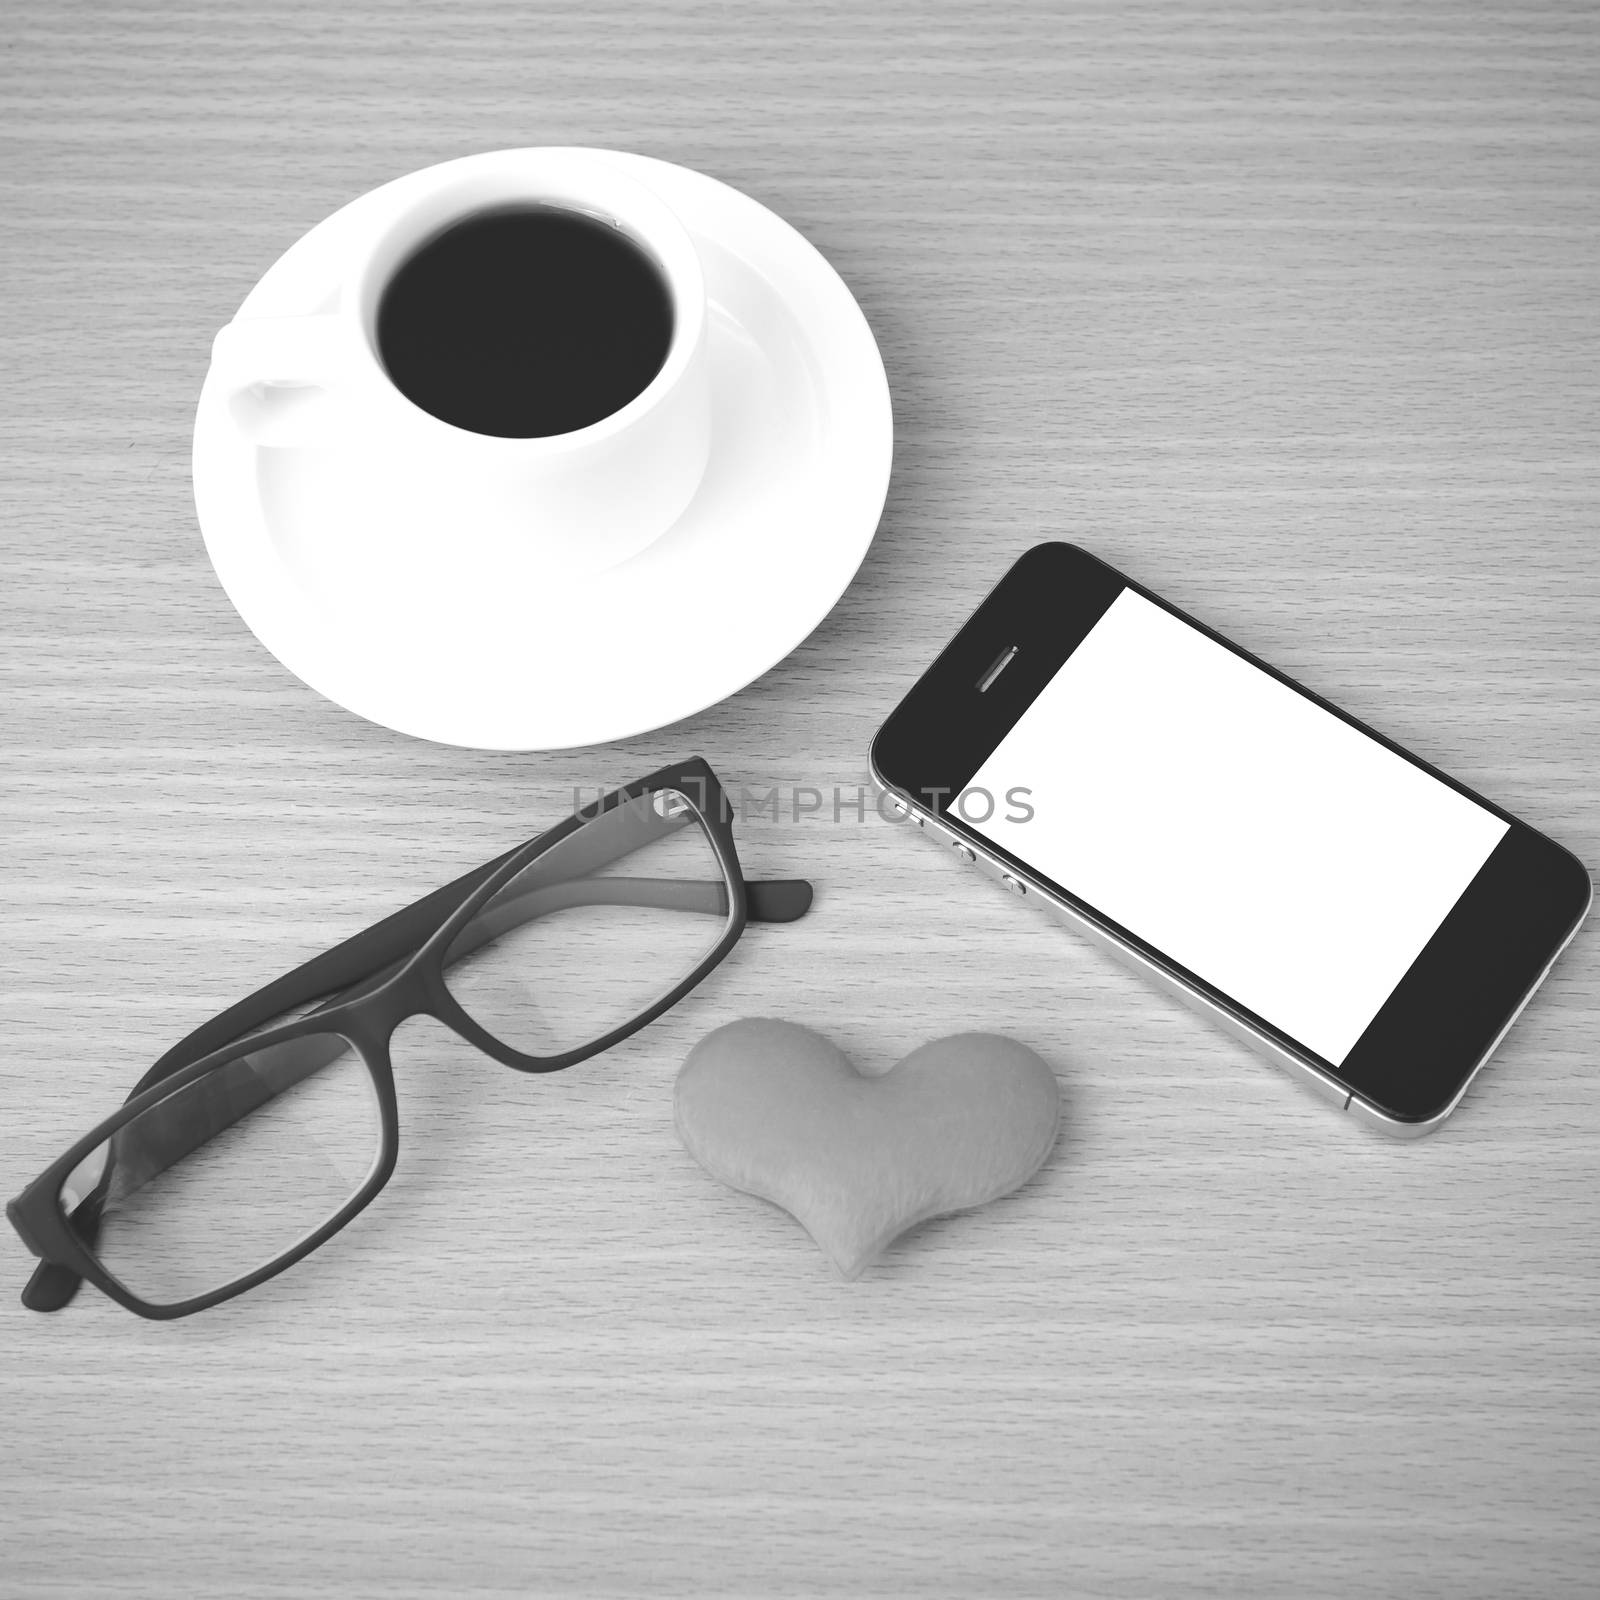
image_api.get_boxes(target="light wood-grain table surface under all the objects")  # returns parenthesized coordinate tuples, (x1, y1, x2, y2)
(0, 0, 1600, 1600)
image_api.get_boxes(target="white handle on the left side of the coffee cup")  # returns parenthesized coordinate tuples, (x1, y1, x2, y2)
(211, 317, 349, 445)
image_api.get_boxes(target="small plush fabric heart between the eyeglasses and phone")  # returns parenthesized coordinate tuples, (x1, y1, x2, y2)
(674, 1018, 1061, 1278)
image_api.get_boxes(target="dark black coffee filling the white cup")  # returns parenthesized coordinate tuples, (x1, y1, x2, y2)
(378, 208, 672, 438)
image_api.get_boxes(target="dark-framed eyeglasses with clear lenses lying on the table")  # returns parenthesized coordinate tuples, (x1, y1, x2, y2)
(6, 758, 811, 1318)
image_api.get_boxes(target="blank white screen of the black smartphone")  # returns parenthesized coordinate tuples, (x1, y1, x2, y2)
(958, 589, 1506, 1066)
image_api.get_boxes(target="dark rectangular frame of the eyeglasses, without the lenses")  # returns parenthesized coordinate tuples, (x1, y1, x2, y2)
(6, 757, 811, 1322)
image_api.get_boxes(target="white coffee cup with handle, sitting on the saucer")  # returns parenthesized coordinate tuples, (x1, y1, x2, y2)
(211, 149, 710, 594)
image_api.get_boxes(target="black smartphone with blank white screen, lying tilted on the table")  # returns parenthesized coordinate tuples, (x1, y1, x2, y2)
(872, 544, 1592, 1136)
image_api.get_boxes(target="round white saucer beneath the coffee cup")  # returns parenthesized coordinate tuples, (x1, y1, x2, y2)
(194, 152, 893, 750)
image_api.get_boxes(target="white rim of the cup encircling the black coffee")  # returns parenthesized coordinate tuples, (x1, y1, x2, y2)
(341, 147, 706, 456)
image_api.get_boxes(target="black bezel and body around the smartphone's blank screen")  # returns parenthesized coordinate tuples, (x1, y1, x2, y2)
(872, 542, 1592, 1125)
